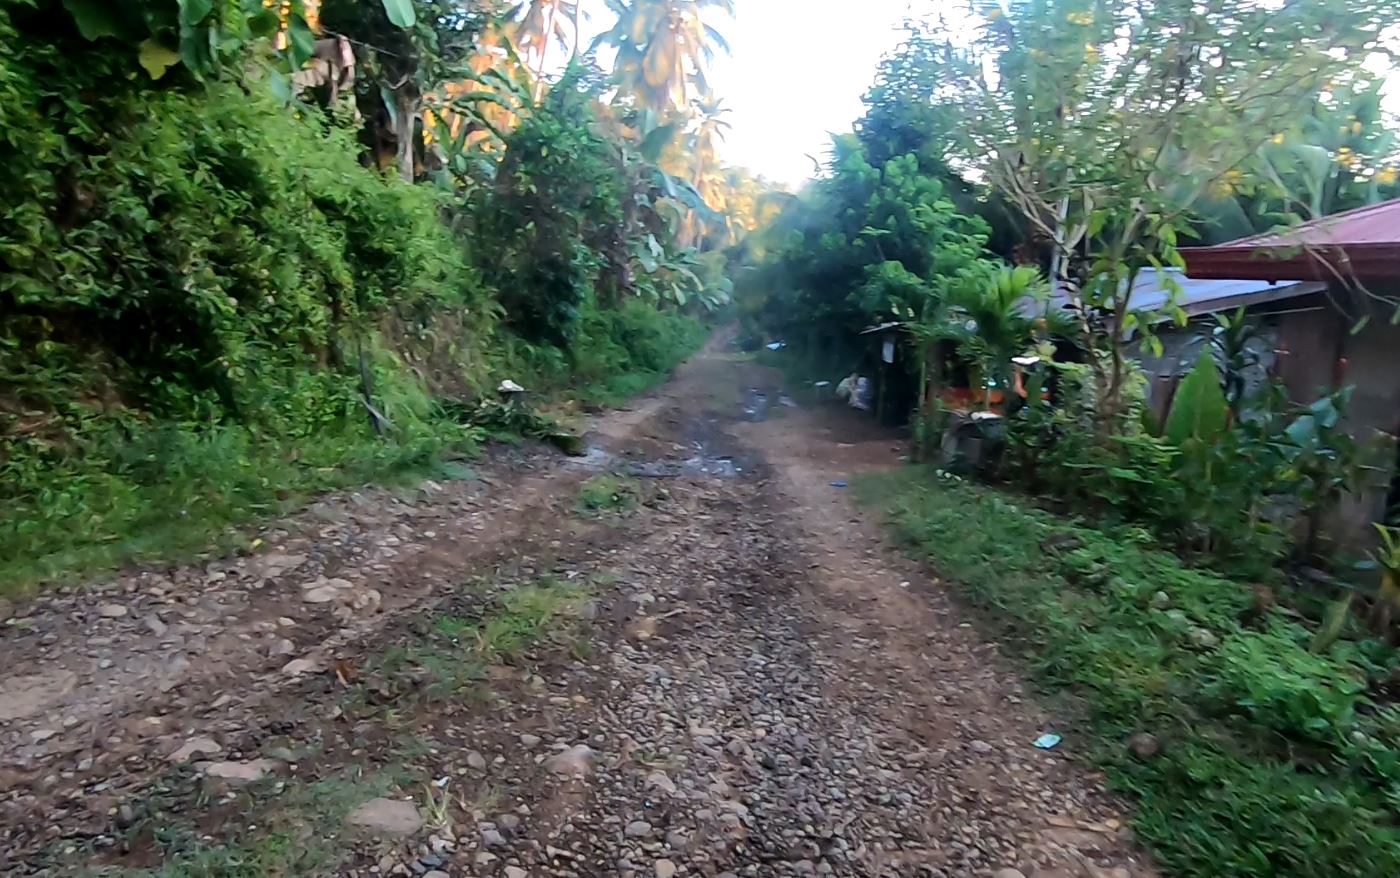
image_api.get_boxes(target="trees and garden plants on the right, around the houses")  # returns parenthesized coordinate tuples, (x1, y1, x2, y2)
(739, 0, 1400, 574)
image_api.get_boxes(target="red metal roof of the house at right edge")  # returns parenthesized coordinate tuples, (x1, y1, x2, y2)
(1182, 199, 1400, 281)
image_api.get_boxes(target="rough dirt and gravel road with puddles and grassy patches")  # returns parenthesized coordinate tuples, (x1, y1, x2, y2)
(0, 349, 1154, 878)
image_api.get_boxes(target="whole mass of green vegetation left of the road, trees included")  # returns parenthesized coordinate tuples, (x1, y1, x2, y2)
(0, 0, 750, 591)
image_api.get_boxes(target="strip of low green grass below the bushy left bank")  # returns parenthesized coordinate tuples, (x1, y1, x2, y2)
(0, 424, 479, 597)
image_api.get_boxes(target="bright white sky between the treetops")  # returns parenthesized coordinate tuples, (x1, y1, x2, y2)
(584, 0, 934, 186)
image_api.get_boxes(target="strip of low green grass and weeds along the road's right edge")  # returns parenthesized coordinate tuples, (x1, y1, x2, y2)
(855, 468, 1400, 878)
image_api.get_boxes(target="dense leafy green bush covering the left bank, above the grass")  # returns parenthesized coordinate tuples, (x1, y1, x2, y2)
(0, 33, 493, 434)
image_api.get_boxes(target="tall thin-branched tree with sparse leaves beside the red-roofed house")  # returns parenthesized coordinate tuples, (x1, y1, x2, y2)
(912, 0, 1400, 424)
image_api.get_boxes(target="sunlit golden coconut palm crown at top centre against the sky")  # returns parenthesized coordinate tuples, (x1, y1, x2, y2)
(594, 0, 734, 116)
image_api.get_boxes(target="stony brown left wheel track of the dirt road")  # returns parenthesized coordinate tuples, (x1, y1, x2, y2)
(0, 358, 716, 871)
